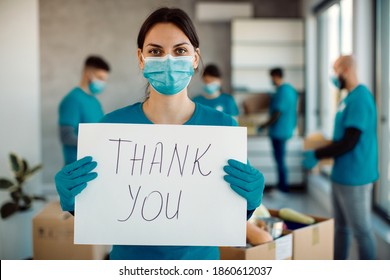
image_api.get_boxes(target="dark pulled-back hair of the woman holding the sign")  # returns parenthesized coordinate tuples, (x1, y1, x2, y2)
(137, 7, 199, 50)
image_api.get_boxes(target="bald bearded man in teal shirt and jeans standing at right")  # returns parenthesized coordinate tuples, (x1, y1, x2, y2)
(303, 56, 379, 259)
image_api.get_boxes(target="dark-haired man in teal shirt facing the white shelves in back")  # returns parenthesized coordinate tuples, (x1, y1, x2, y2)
(260, 68, 298, 192)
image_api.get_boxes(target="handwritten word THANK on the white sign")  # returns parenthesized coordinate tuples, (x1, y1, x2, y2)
(108, 138, 211, 177)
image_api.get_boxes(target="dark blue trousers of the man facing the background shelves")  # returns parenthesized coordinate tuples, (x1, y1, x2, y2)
(271, 138, 288, 192)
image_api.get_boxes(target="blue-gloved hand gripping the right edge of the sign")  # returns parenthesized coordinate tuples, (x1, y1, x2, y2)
(223, 159, 264, 210)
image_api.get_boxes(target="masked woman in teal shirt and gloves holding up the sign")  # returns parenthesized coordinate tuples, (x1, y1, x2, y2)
(55, 8, 264, 259)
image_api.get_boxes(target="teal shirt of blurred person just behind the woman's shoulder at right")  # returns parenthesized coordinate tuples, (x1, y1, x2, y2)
(193, 93, 239, 117)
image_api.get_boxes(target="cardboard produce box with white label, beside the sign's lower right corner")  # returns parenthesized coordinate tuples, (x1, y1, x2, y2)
(219, 232, 293, 260)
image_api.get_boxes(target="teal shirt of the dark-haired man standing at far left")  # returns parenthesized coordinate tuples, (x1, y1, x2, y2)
(59, 87, 104, 165)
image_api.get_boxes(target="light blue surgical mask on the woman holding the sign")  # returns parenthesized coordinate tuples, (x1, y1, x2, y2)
(142, 54, 194, 95)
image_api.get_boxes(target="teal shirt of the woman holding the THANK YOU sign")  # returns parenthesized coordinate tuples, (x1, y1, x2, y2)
(101, 103, 237, 260)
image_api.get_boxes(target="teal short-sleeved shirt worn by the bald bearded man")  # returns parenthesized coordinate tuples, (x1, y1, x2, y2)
(331, 85, 379, 186)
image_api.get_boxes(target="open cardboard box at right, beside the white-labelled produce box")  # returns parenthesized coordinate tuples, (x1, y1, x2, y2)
(269, 209, 334, 260)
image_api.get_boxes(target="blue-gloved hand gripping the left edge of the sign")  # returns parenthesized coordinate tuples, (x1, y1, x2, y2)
(54, 156, 97, 211)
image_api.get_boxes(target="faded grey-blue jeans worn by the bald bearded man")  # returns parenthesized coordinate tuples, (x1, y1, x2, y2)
(332, 183, 376, 260)
